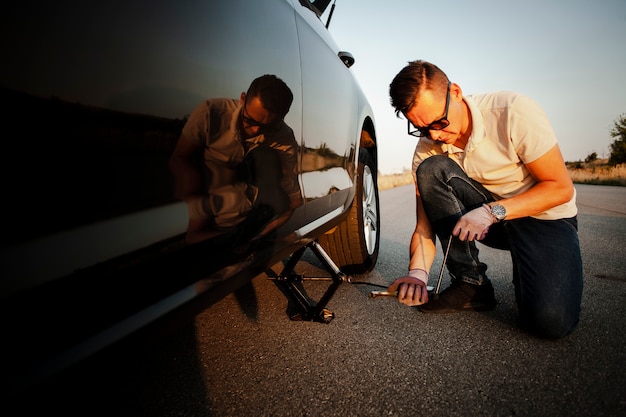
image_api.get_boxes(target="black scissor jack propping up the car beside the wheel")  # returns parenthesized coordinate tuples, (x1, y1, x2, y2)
(268, 241, 350, 323)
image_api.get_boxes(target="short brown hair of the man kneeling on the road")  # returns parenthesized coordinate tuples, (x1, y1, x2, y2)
(389, 60, 449, 117)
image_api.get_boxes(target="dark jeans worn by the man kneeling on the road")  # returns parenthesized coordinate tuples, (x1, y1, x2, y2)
(417, 155, 583, 338)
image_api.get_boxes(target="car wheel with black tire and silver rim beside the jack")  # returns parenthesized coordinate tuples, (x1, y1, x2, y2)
(318, 149, 380, 274)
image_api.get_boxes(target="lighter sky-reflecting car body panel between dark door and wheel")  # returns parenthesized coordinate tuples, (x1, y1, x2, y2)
(294, 1, 360, 220)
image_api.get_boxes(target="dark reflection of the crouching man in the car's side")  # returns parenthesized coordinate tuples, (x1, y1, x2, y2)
(170, 75, 303, 243)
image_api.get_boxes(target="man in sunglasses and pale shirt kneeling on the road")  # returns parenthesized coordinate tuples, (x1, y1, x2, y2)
(389, 61, 583, 338)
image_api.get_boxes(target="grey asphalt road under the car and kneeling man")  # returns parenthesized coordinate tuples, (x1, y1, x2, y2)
(14, 185, 626, 417)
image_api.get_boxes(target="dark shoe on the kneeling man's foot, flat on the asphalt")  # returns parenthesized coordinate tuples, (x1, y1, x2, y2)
(419, 279, 498, 314)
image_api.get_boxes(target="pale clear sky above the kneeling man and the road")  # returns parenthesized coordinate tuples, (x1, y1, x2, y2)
(322, 0, 626, 174)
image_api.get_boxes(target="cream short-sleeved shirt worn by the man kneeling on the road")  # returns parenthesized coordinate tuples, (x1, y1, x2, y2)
(413, 91, 577, 220)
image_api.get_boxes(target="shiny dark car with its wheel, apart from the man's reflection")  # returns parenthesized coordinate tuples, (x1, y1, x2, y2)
(0, 0, 380, 392)
